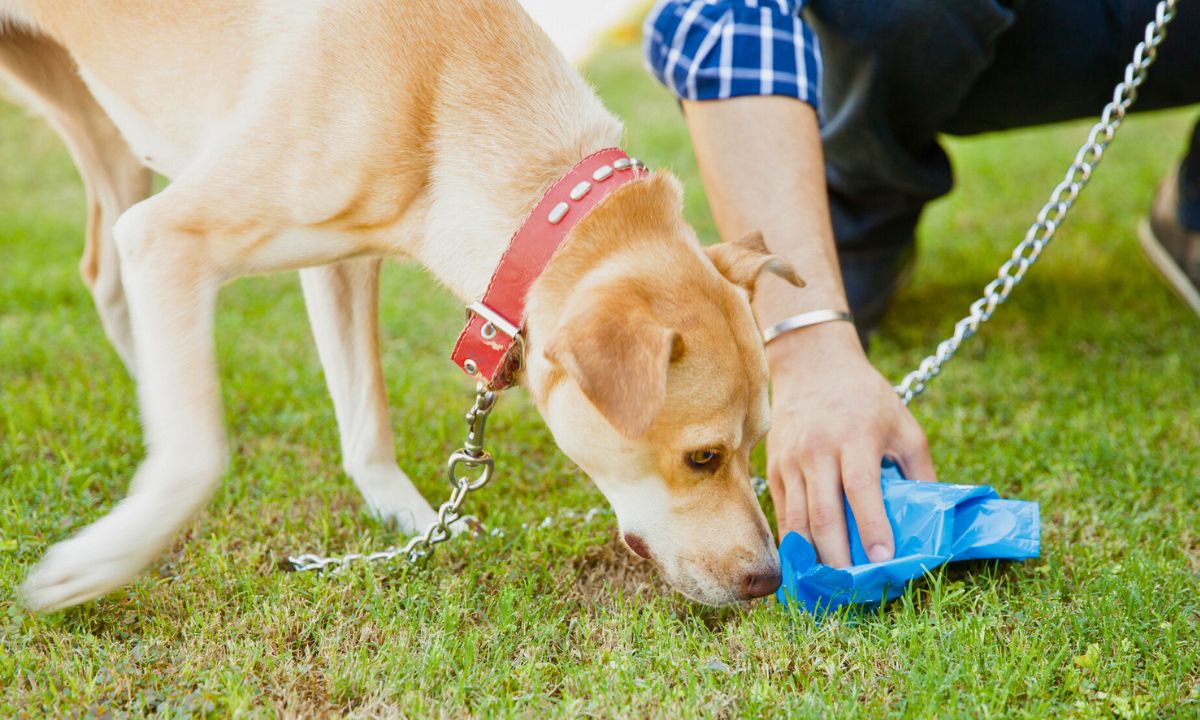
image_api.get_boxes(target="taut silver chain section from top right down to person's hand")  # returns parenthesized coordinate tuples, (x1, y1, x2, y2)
(895, 0, 1176, 404)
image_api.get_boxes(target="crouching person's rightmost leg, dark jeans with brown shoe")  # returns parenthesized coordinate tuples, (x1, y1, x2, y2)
(946, 0, 1200, 303)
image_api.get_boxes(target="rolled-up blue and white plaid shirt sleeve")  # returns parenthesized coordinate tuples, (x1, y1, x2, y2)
(643, 0, 821, 108)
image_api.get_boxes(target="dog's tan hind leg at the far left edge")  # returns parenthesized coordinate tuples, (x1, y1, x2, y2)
(0, 26, 151, 373)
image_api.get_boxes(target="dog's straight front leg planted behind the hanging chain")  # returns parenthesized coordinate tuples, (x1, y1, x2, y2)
(300, 258, 437, 533)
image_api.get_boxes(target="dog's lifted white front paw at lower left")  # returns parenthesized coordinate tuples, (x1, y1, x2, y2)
(20, 498, 162, 612)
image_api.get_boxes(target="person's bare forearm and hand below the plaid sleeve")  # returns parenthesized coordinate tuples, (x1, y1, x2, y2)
(684, 96, 935, 566)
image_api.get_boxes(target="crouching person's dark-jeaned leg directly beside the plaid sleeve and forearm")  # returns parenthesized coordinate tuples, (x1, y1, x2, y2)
(805, 0, 1015, 330)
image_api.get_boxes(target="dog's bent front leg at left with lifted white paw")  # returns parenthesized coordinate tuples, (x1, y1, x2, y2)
(22, 190, 228, 611)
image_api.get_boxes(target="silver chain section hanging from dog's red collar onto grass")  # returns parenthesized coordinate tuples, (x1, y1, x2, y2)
(288, 383, 496, 572)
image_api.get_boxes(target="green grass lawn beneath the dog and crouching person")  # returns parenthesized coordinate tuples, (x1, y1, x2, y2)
(0, 23, 1200, 718)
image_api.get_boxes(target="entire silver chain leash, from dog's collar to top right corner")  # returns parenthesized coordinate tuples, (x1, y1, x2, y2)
(288, 0, 1177, 572)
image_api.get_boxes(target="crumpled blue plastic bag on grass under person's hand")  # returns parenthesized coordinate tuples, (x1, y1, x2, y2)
(775, 462, 1042, 614)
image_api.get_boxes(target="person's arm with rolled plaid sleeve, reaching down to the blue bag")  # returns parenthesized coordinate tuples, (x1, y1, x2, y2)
(647, 0, 934, 566)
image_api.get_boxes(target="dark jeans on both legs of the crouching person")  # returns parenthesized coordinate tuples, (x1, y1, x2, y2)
(805, 0, 1200, 319)
